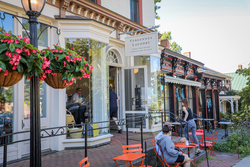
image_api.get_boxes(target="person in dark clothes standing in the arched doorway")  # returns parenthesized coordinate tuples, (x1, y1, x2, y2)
(109, 84, 122, 133)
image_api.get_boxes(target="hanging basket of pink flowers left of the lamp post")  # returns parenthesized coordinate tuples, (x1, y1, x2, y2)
(0, 32, 44, 86)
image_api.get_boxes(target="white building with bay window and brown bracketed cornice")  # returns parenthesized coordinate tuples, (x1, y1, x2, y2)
(0, 0, 163, 161)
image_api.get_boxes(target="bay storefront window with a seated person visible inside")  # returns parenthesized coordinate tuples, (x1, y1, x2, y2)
(66, 39, 109, 138)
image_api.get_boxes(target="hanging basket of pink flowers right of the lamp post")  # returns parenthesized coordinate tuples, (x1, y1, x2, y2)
(41, 45, 93, 89)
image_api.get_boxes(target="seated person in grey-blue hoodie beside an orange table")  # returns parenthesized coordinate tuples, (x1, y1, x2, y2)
(156, 123, 190, 167)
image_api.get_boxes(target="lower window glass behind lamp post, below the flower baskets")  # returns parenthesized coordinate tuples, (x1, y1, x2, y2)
(24, 80, 46, 119)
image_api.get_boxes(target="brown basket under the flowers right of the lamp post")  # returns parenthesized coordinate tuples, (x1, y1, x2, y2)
(44, 73, 70, 89)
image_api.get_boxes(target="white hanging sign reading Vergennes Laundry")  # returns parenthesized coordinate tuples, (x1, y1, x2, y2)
(125, 32, 158, 56)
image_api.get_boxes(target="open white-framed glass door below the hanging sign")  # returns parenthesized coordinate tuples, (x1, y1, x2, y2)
(122, 66, 149, 131)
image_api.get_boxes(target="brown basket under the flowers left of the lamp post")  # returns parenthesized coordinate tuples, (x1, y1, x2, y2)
(0, 71, 23, 87)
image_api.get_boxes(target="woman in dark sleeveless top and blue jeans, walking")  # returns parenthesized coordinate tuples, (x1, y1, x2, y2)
(182, 99, 200, 154)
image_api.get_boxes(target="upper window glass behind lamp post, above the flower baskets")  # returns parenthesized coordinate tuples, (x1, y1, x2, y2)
(22, 19, 48, 47)
